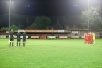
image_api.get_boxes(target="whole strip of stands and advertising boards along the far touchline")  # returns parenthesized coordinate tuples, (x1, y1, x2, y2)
(0, 29, 102, 39)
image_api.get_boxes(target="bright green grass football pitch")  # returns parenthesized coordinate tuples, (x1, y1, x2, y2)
(0, 39, 102, 68)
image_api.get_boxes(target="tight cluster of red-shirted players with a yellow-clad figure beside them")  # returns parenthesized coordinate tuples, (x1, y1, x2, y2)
(84, 32, 95, 44)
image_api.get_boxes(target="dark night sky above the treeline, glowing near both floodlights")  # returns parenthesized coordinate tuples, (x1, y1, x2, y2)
(0, 0, 101, 16)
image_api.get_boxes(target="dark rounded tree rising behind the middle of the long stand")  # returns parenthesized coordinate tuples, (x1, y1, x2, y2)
(32, 16, 51, 29)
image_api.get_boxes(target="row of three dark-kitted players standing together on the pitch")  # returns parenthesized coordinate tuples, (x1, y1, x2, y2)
(9, 30, 26, 46)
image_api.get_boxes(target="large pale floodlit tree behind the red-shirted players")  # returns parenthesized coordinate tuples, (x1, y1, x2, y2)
(81, 7, 102, 30)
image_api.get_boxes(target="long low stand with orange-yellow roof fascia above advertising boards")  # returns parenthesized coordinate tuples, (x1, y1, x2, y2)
(25, 30, 70, 39)
